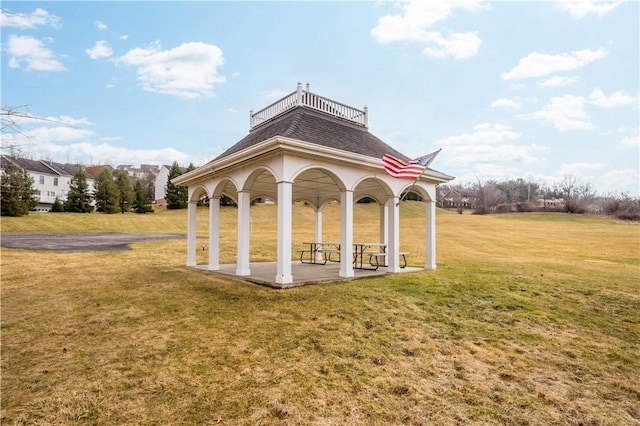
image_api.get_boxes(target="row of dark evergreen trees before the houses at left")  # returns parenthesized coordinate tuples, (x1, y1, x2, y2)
(0, 162, 195, 216)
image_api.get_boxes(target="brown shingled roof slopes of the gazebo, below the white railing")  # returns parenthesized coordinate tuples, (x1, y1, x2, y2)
(213, 105, 408, 161)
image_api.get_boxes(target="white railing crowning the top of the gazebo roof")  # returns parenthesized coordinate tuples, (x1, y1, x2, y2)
(249, 83, 368, 129)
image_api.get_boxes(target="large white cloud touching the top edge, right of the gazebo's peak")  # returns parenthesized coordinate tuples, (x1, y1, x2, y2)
(371, 0, 487, 59)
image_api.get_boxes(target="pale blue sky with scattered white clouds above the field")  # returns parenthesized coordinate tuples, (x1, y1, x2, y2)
(1, 0, 640, 195)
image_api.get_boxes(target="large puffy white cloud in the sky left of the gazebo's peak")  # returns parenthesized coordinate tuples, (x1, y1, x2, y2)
(116, 42, 225, 99)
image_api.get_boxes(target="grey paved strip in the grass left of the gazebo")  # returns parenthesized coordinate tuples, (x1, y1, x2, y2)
(0, 232, 186, 251)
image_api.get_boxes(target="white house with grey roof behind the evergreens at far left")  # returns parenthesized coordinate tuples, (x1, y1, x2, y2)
(0, 155, 94, 212)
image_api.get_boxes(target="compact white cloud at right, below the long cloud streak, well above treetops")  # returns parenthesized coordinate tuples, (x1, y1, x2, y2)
(519, 95, 596, 131)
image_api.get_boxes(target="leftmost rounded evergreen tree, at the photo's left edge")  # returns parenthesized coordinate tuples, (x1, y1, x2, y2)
(0, 161, 38, 216)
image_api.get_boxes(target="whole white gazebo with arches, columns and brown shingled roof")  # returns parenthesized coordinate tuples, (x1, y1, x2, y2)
(172, 83, 453, 288)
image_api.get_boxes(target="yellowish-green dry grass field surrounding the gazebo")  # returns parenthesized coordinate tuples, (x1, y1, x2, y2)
(0, 202, 640, 425)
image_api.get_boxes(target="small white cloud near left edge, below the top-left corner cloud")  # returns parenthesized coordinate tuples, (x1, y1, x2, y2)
(6, 34, 66, 71)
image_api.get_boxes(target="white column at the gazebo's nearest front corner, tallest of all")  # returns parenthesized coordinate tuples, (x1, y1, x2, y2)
(276, 182, 293, 284)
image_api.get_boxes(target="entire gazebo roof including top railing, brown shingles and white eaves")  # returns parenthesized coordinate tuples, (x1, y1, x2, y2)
(174, 83, 453, 188)
